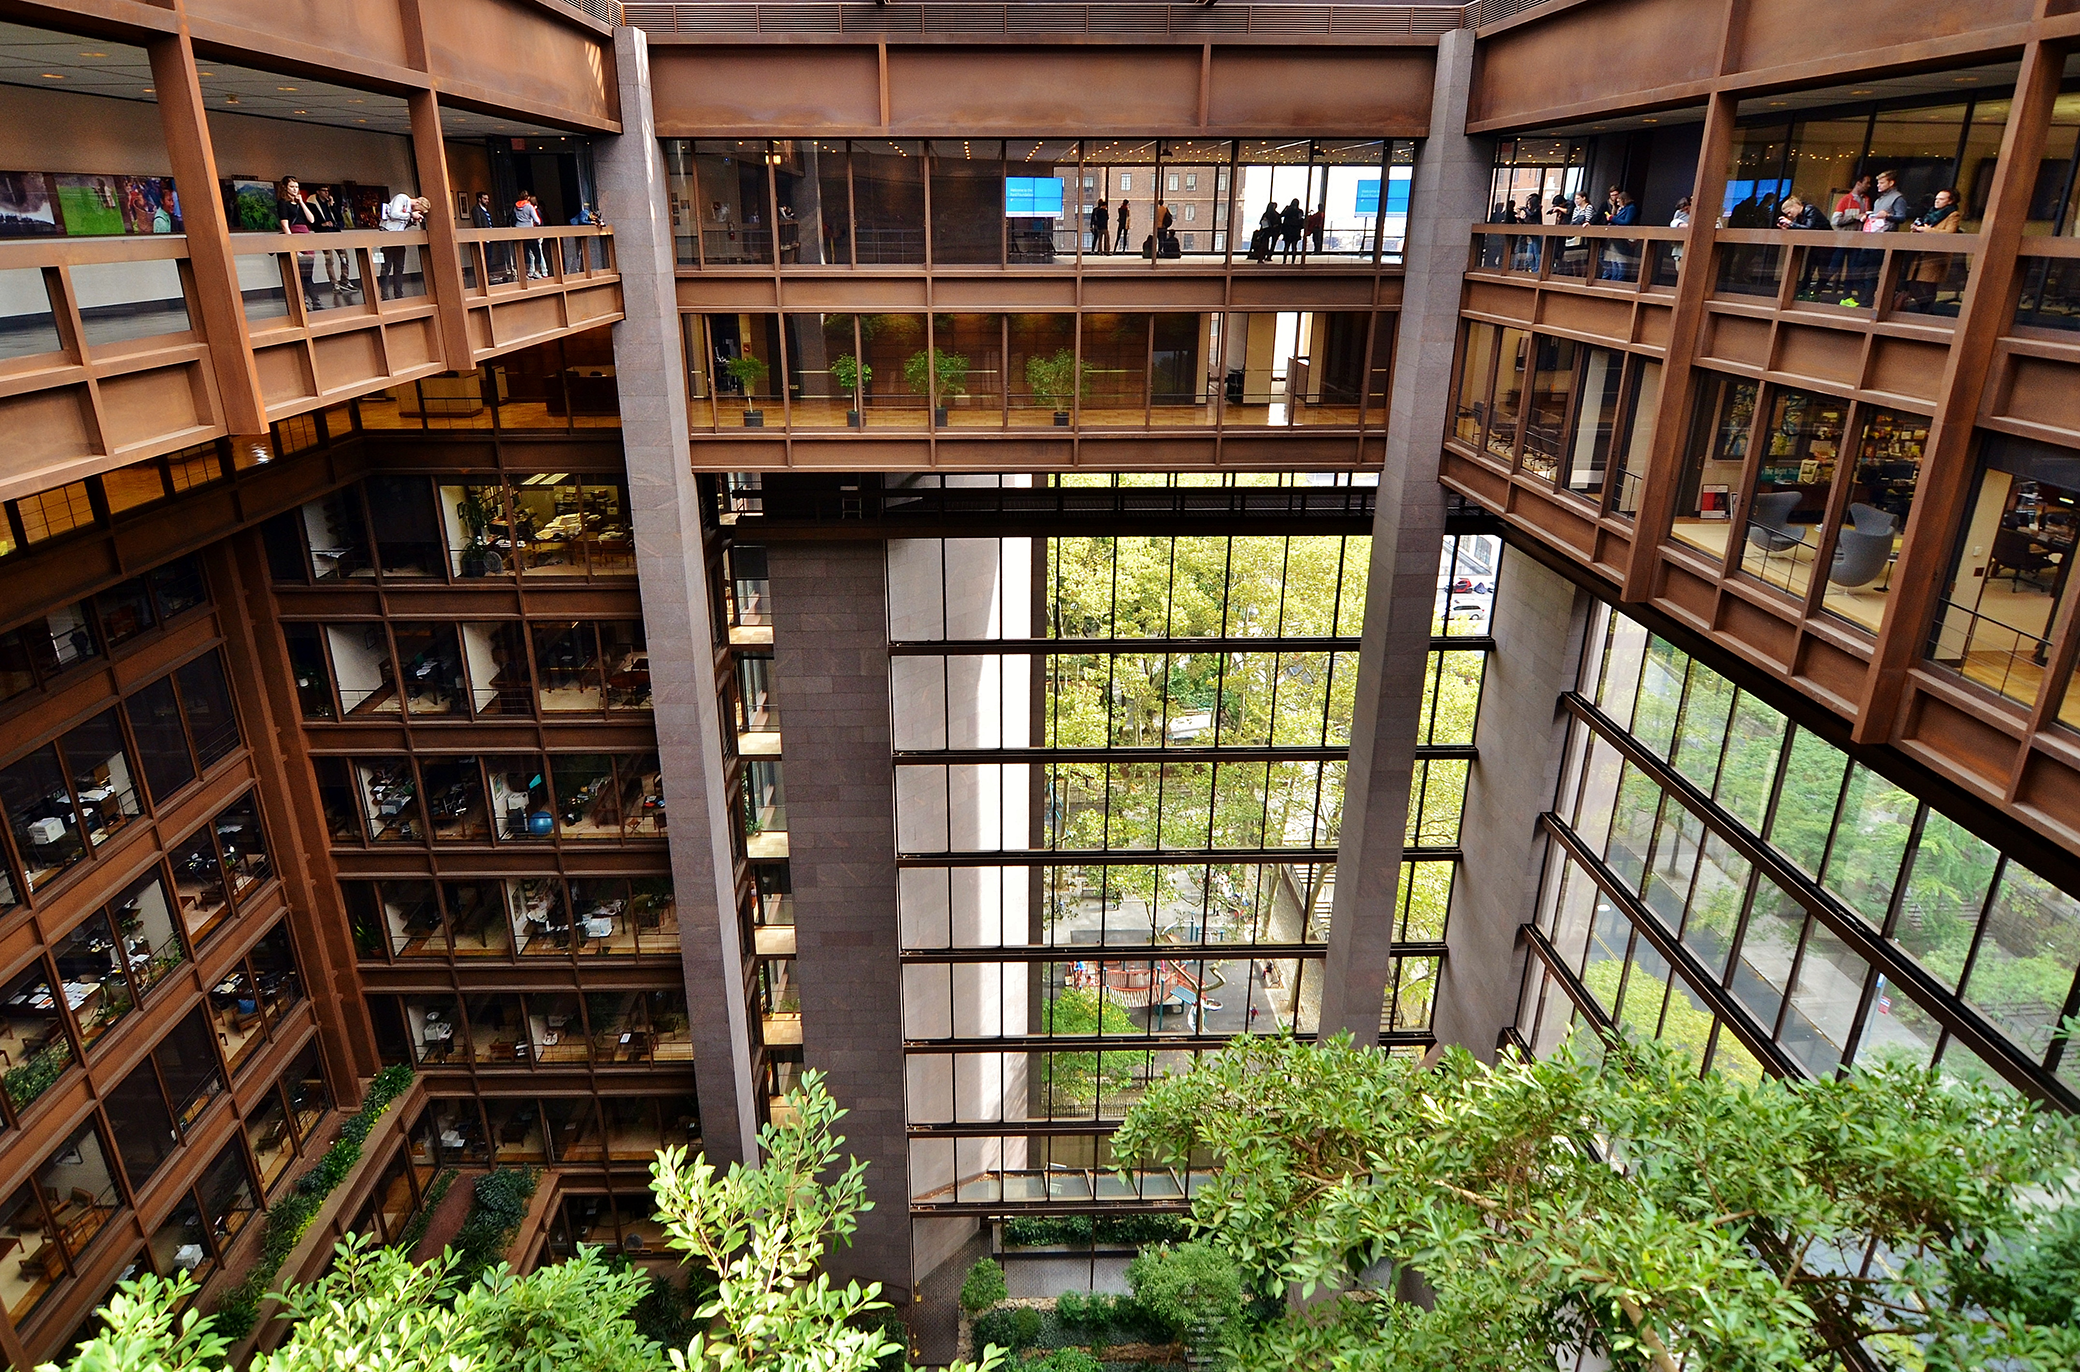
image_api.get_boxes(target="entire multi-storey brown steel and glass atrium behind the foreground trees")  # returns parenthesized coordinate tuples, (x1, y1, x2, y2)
(0, 0, 2080, 1368)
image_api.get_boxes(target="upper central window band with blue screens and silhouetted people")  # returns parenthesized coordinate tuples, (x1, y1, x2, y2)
(666, 137, 1414, 268)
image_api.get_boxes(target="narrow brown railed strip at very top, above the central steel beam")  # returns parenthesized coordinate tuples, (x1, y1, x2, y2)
(622, 0, 1473, 37)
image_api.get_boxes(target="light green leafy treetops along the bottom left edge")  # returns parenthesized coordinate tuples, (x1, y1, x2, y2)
(40, 1073, 1003, 1372)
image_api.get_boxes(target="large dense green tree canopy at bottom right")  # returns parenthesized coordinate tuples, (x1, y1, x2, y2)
(1113, 1037, 2080, 1372)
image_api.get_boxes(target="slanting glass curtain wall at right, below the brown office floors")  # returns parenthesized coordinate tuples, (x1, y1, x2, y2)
(1518, 607, 2080, 1096)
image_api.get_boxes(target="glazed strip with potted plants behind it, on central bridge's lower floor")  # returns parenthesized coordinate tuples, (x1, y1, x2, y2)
(690, 310, 1389, 432)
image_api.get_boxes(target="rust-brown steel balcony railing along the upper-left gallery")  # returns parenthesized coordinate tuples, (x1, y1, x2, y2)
(0, 227, 622, 499)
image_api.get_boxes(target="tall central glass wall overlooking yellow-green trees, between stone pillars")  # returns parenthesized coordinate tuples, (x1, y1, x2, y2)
(888, 536, 1369, 1206)
